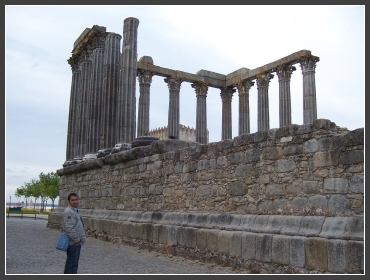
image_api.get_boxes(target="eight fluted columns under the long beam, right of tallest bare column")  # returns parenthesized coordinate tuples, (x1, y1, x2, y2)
(134, 56, 319, 144)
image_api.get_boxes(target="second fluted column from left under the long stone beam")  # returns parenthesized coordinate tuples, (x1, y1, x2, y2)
(164, 77, 182, 140)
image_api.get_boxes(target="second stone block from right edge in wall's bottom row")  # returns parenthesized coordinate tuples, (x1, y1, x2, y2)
(328, 239, 347, 273)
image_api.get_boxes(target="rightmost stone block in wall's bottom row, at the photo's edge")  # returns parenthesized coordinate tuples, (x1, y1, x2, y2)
(345, 241, 364, 274)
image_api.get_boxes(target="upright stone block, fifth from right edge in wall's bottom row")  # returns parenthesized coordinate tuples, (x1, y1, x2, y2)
(271, 235, 290, 265)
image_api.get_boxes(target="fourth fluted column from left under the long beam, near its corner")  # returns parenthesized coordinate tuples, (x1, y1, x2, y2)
(220, 87, 236, 140)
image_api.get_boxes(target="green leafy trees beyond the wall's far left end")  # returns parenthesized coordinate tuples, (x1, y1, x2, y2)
(15, 172, 59, 211)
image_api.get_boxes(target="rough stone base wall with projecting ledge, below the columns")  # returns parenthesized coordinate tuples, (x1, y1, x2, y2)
(48, 119, 364, 273)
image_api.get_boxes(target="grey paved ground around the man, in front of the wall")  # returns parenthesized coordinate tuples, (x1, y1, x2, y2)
(5, 215, 240, 274)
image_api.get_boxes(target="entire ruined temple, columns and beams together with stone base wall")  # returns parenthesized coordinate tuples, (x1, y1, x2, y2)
(47, 18, 365, 274)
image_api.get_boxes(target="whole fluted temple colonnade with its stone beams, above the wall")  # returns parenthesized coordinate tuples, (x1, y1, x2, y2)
(66, 17, 319, 164)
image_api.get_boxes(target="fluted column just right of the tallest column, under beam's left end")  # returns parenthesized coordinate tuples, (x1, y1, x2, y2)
(137, 70, 153, 137)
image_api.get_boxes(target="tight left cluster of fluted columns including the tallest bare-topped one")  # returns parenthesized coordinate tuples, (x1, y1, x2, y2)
(66, 18, 138, 160)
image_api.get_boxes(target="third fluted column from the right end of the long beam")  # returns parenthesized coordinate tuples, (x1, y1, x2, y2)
(257, 73, 274, 131)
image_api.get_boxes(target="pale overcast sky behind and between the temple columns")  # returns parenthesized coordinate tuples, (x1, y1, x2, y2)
(5, 5, 365, 205)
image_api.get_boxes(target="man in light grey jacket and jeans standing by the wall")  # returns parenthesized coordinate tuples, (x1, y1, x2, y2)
(62, 193, 86, 274)
